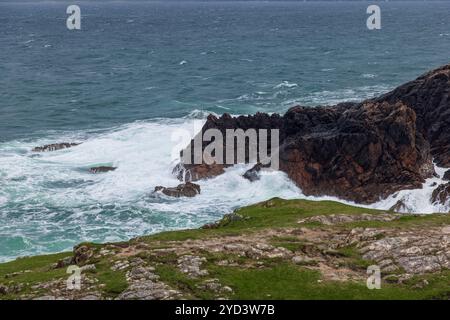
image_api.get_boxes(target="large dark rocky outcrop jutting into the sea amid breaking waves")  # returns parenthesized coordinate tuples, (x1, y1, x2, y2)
(177, 66, 450, 203)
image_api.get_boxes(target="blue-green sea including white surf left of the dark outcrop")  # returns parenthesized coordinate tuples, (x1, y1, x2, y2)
(0, 1, 450, 260)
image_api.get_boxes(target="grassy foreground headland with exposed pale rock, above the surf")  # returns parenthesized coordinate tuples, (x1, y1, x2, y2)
(0, 198, 450, 300)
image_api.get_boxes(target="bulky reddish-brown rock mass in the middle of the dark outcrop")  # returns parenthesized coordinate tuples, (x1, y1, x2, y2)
(280, 102, 433, 203)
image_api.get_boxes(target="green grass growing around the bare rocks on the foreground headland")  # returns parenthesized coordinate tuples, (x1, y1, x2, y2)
(0, 198, 450, 299)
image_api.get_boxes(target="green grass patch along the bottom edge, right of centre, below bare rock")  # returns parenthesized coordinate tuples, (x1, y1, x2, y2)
(207, 263, 450, 300)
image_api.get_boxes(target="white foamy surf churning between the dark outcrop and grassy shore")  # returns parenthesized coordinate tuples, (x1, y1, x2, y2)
(0, 114, 450, 260)
